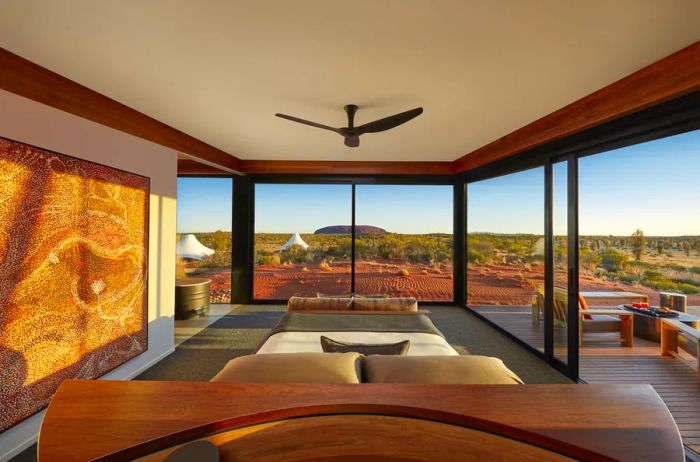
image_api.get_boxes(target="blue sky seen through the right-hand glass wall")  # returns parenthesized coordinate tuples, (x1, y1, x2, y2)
(468, 131, 700, 236)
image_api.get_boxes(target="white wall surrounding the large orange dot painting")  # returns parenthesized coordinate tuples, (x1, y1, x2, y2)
(0, 90, 177, 460)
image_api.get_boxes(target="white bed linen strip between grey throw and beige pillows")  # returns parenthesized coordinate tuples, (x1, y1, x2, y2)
(256, 332, 459, 356)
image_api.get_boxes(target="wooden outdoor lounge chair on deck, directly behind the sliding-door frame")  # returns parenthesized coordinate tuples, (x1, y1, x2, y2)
(532, 287, 634, 347)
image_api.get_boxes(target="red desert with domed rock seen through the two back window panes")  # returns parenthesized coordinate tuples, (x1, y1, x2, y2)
(254, 229, 453, 301)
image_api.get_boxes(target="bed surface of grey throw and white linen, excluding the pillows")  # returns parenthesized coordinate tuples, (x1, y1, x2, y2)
(256, 312, 459, 356)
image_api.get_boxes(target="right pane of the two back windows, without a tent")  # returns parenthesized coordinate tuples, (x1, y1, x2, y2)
(355, 185, 454, 301)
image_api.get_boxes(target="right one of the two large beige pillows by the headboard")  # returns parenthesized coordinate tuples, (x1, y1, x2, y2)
(362, 355, 523, 385)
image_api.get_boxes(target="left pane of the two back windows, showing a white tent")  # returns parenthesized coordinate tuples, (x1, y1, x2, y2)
(253, 184, 352, 300)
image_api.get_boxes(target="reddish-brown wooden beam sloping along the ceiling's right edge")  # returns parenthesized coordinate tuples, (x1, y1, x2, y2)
(453, 41, 700, 173)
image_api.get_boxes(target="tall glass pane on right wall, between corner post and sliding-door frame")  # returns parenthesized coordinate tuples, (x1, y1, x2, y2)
(466, 167, 545, 350)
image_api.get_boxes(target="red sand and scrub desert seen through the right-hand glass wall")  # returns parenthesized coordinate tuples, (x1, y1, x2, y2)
(467, 230, 700, 306)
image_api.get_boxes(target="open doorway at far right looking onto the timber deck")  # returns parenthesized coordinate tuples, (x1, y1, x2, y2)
(578, 131, 700, 445)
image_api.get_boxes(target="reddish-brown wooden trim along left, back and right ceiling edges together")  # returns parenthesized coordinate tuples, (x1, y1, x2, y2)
(0, 42, 700, 175)
